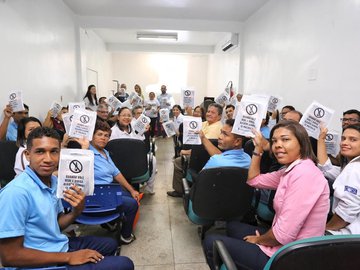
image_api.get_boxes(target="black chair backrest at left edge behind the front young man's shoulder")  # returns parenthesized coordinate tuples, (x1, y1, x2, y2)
(0, 141, 18, 186)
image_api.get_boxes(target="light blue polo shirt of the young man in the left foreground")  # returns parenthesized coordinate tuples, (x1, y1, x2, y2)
(0, 166, 68, 252)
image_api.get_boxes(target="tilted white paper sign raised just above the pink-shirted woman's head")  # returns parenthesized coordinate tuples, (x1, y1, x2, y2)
(300, 101, 334, 139)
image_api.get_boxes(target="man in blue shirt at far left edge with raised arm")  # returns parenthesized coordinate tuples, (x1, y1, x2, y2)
(0, 104, 29, 141)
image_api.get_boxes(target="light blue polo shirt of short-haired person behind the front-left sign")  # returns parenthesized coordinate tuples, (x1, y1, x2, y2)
(89, 144, 120, 185)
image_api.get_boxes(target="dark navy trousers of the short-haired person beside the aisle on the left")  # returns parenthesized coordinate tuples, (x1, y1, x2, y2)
(121, 190, 139, 238)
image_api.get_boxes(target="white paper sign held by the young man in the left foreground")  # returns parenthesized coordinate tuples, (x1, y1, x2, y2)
(56, 149, 94, 198)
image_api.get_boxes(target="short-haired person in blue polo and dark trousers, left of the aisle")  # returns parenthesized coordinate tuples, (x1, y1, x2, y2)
(89, 121, 139, 245)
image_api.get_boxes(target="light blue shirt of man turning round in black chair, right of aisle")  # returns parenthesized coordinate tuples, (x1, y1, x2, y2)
(203, 148, 251, 169)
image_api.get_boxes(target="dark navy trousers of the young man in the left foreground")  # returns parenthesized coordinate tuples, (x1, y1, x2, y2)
(66, 236, 134, 270)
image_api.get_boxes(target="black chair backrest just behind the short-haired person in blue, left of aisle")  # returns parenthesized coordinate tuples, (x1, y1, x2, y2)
(106, 139, 148, 181)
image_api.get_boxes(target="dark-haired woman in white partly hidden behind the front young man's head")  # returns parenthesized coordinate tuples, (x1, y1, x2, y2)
(14, 117, 42, 175)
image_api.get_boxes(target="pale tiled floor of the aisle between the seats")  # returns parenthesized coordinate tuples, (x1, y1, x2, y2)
(82, 138, 209, 270)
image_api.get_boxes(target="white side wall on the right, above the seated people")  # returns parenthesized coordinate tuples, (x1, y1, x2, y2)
(240, 0, 360, 130)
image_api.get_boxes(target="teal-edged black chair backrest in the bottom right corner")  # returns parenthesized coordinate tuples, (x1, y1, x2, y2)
(264, 235, 360, 270)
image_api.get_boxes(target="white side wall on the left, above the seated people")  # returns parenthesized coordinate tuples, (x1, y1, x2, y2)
(0, 0, 78, 118)
